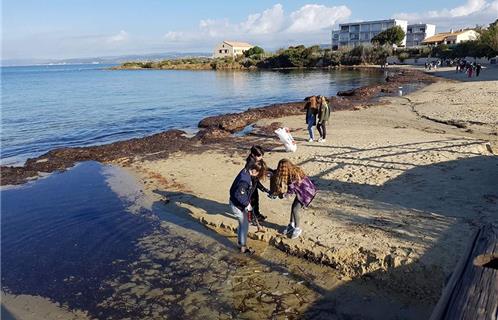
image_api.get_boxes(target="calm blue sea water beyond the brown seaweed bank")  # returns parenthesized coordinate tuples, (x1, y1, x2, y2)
(1, 65, 382, 164)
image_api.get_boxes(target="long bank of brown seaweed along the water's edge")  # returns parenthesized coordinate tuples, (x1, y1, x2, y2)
(0, 69, 434, 185)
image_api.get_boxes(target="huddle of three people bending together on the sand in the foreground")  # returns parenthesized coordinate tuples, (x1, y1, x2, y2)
(230, 146, 317, 253)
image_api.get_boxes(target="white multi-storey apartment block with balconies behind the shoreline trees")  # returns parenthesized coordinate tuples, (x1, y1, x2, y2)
(332, 19, 408, 50)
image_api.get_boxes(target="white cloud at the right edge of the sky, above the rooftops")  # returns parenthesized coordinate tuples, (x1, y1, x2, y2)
(394, 0, 498, 31)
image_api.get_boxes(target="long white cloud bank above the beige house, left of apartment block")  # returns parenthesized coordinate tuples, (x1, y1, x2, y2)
(163, 4, 351, 48)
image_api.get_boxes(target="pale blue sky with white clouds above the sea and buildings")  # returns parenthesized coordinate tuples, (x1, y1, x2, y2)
(1, 0, 498, 60)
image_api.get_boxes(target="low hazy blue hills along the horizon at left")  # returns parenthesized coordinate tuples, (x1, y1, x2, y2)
(1, 52, 211, 66)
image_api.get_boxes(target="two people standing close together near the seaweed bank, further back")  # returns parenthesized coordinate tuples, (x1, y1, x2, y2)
(304, 96, 330, 142)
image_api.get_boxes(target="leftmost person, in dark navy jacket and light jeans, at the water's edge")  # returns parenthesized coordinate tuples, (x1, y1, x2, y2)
(230, 161, 265, 253)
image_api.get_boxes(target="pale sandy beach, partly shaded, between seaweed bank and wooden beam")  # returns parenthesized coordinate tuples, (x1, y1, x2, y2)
(126, 72, 498, 299)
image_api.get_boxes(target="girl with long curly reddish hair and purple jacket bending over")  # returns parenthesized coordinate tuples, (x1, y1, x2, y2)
(270, 159, 317, 239)
